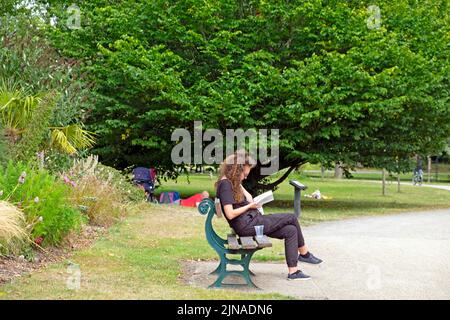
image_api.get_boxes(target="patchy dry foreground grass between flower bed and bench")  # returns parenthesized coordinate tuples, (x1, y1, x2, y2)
(0, 205, 287, 300)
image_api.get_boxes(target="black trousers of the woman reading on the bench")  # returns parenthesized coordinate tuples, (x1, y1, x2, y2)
(232, 210, 305, 268)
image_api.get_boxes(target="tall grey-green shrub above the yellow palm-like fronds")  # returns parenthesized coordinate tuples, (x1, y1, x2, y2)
(0, 12, 93, 126)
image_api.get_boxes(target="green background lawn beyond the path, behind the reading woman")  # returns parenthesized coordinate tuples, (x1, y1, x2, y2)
(158, 174, 450, 225)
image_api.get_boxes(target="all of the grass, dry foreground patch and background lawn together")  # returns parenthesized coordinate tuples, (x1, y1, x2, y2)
(0, 175, 450, 299)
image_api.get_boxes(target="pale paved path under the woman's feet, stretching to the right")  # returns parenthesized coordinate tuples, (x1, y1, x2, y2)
(189, 209, 450, 299)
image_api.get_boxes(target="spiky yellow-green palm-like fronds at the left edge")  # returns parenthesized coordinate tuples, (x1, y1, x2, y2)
(0, 80, 95, 154)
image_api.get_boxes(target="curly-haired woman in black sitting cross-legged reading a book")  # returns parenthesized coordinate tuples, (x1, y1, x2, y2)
(215, 152, 322, 280)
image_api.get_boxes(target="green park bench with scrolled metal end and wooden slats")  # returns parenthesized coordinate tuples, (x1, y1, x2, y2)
(198, 198, 272, 288)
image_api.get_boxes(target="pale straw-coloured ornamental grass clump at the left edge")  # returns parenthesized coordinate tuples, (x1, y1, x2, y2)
(0, 201, 26, 255)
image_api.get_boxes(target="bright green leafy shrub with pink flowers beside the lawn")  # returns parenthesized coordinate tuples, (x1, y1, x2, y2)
(0, 162, 83, 245)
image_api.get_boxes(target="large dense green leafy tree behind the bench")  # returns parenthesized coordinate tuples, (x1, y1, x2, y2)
(36, 0, 450, 190)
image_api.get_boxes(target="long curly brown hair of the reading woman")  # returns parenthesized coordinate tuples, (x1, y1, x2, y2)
(215, 151, 255, 202)
